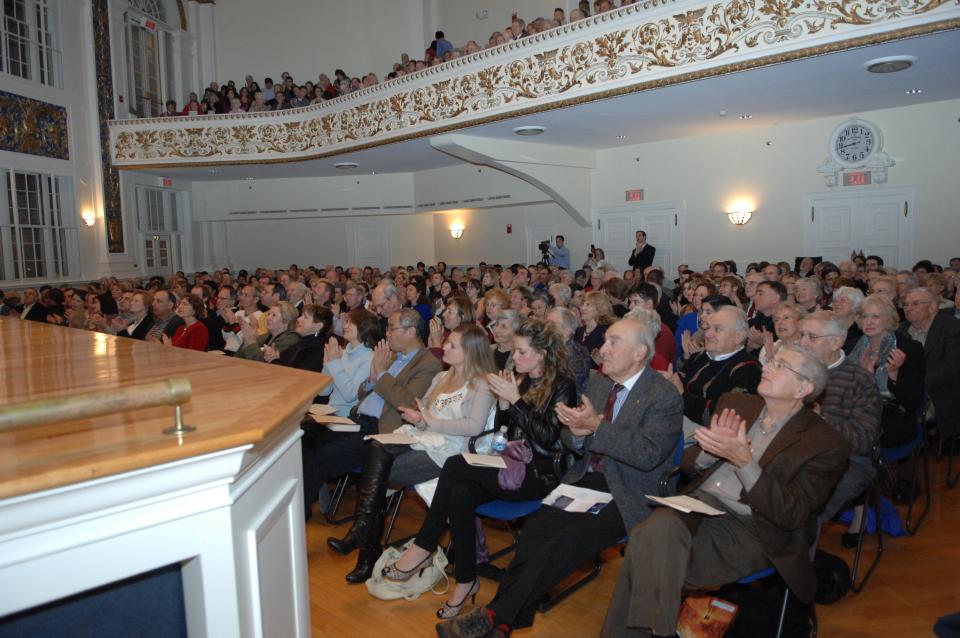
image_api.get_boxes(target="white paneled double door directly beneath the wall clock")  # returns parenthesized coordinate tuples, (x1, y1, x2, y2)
(804, 187, 916, 268)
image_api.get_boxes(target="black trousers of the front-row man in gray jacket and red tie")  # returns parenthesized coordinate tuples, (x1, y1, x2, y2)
(488, 473, 627, 629)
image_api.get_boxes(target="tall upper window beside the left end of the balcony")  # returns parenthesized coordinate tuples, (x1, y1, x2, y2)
(126, 0, 174, 117)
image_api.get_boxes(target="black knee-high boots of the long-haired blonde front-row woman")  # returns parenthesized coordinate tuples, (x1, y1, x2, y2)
(327, 441, 393, 583)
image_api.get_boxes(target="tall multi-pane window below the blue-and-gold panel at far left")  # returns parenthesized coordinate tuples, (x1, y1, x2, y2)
(0, 170, 79, 280)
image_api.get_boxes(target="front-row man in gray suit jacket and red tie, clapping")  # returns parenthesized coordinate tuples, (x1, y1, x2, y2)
(437, 318, 683, 637)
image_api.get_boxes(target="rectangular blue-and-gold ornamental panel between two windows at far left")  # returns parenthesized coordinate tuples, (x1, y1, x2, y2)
(0, 91, 70, 159)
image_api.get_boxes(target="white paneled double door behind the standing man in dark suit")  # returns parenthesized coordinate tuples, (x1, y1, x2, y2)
(593, 202, 684, 275)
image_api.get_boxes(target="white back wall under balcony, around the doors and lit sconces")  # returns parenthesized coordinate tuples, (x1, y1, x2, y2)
(180, 100, 960, 268)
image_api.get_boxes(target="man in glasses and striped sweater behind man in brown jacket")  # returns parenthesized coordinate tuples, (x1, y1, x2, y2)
(800, 310, 881, 542)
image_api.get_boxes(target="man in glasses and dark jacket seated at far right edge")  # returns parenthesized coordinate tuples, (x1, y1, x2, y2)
(900, 288, 960, 448)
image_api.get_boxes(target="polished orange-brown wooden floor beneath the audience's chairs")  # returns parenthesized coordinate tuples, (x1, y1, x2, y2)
(307, 459, 960, 638)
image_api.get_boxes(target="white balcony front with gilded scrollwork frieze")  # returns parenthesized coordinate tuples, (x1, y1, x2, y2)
(111, 0, 960, 167)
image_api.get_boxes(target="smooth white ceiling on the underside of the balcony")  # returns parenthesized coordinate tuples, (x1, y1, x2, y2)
(148, 31, 960, 181)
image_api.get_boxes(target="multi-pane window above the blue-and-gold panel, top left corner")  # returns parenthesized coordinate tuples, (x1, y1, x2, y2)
(0, 0, 61, 87)
